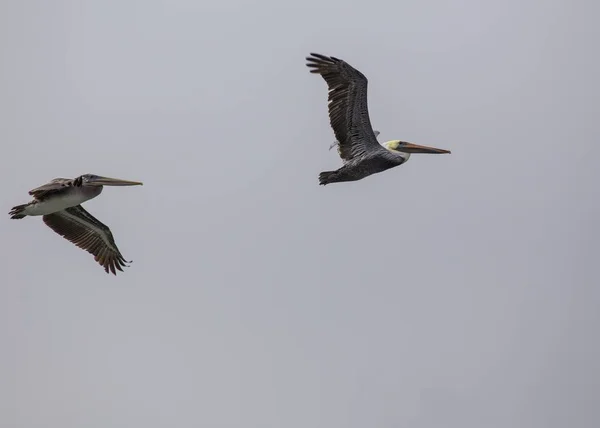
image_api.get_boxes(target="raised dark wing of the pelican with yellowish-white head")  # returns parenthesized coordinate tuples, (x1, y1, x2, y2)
(306, 53, 385, 162)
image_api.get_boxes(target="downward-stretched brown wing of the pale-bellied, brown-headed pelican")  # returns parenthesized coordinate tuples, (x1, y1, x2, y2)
(43, 205, 131, 275)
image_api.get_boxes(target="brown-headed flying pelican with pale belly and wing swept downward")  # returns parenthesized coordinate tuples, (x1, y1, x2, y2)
(9, 174, 142, 275)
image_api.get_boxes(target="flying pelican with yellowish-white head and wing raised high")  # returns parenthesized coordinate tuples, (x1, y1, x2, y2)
(306, 53, 450, 185)
